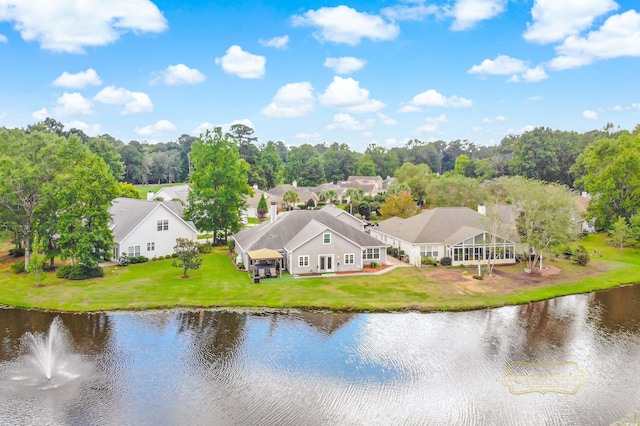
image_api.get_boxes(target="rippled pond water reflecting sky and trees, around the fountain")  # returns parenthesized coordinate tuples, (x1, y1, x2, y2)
(0, 286, 640, 425)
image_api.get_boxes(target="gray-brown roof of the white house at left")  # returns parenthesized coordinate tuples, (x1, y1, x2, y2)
(109, 197, 198, 243)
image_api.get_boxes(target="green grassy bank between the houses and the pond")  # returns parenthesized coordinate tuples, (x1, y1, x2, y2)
(0, 236, 640, 311)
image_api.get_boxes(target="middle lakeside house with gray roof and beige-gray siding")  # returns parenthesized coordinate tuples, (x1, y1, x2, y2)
(233, 205, 387, 275)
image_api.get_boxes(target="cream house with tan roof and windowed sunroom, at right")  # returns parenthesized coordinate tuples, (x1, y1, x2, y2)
(369, 207, 516, 266)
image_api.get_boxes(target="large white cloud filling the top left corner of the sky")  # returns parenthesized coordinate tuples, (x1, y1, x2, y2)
(0, 0, 168, 53)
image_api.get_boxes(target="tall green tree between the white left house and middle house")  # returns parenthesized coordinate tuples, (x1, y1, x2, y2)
(185, 127, 253, 243)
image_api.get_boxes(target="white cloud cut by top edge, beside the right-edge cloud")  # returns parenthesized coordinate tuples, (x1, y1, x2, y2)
(523, 0, 618, 43)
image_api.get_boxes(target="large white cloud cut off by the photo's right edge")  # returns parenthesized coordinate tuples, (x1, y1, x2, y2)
(549, 10, 640, 70)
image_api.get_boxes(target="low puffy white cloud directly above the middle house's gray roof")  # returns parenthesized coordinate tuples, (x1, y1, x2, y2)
(260, 81, 316, 118)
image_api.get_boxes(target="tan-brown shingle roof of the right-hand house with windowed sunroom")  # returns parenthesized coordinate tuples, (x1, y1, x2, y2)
(376, 207, 510, 244)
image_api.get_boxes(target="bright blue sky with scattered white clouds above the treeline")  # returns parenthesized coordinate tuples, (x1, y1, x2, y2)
(0, 0, 640, 152)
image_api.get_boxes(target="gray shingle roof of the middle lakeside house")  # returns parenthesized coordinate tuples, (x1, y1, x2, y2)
(234, 209, 386, 252)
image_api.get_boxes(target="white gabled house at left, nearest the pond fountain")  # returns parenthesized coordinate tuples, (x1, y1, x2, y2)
(109, 198, 198, 259)
